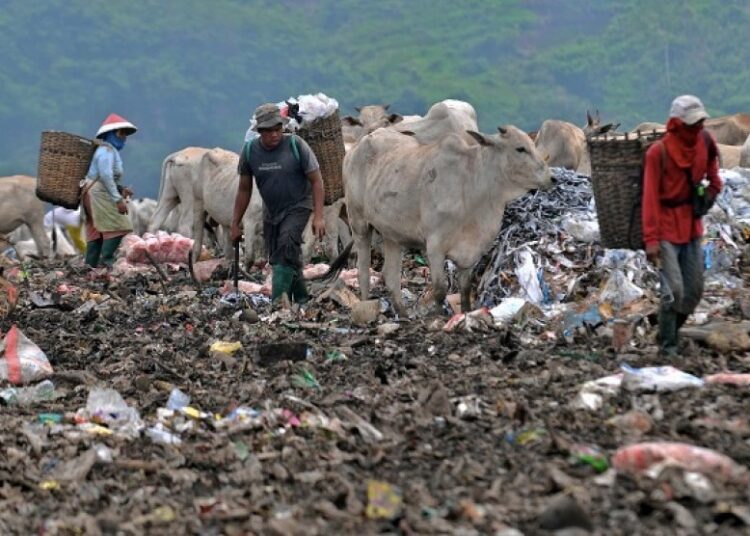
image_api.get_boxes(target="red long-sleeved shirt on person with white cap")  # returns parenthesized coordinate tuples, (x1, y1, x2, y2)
(642, 134, 722, 246)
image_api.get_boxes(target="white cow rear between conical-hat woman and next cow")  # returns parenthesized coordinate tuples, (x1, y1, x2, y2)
(148, 147, 208, 237)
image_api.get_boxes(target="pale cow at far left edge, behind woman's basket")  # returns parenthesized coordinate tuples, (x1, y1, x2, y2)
(0, 175, 52, 257)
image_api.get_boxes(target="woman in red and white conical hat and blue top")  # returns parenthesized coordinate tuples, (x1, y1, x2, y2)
(82, 114, 138, 268)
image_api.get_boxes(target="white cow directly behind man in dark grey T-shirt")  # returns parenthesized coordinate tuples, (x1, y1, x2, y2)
(192, 147, 263, 266)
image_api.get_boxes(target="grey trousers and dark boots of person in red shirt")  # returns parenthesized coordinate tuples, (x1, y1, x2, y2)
(659, 238, 703, 354)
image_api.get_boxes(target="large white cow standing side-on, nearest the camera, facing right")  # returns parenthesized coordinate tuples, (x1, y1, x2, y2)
(344, 126, 551, 314)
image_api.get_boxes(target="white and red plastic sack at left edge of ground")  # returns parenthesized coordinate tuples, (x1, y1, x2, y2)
(0, 324, 52, 385)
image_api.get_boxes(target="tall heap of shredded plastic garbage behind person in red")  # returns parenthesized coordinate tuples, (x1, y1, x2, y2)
(477, 168, 750, 330)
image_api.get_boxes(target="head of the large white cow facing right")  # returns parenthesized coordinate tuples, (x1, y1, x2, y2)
(467, 125, 552, 193)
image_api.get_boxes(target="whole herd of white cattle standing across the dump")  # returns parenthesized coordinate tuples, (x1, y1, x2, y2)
(0, 100, 750, 309)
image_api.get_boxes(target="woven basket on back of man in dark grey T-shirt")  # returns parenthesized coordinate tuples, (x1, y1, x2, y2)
(298, 111, 344, 205)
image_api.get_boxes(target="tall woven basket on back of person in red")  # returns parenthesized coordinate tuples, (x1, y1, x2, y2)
(588, 130, 664, 249)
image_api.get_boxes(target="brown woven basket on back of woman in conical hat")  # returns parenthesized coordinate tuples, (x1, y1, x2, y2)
(36, 130, 97, 209)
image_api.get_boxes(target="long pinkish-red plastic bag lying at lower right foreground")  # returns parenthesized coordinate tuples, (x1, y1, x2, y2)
(612, 442, 748, 482)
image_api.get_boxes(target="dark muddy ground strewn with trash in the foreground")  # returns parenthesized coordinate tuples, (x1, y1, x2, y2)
(0, 262, 750, 536)
